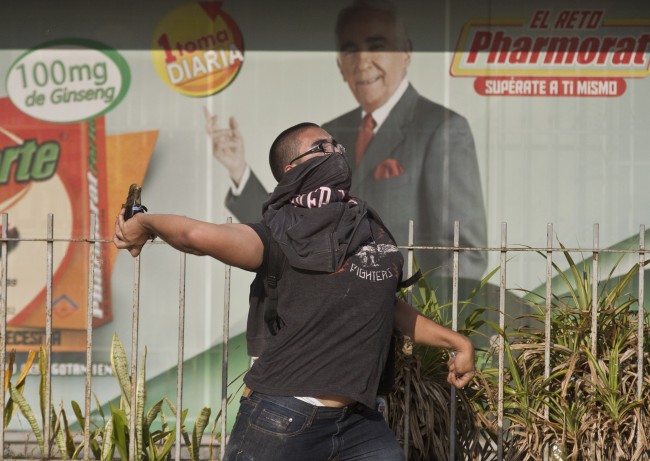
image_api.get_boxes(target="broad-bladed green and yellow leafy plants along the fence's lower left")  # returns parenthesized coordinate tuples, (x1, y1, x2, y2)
(4, 335, 216, 461)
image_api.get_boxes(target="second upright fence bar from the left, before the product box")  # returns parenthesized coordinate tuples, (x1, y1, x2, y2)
(43, 213, 54, 458)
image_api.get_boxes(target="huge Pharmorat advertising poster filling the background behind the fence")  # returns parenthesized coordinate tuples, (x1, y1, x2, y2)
(0, 0, 650, 430)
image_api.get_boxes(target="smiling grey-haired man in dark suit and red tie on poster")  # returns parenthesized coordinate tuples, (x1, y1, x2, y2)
(206, 0, 487, 285)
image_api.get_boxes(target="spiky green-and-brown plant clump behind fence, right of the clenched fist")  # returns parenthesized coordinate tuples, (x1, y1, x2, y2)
(473, 246, 650, 461)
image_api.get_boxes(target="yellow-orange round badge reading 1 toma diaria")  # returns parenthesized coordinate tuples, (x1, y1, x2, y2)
(151, 1, 244, 97)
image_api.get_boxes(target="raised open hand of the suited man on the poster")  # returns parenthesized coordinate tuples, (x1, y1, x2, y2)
(203, 107, 246, 185)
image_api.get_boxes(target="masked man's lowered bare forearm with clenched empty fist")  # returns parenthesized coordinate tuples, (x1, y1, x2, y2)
(394, 300, 475, 388)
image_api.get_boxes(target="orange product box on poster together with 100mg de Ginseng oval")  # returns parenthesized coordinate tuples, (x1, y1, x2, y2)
(0, 39, 155, 352)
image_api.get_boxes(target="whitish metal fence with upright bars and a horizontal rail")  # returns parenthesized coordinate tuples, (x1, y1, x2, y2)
(0, 214, 650, 461)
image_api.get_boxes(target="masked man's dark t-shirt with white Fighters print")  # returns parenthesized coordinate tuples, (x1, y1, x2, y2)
(244, 222, 404, 407)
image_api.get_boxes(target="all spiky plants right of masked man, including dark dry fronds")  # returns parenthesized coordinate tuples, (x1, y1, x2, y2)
(400, 253, 650, 461)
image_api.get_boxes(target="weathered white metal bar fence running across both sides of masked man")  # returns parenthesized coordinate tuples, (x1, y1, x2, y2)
(0, 214, 650, 461)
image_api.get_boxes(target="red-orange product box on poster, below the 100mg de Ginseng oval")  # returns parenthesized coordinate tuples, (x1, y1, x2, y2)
(0, 98, 158, 344)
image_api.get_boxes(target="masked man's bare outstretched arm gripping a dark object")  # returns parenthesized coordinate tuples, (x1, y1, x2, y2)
(113, 209, 264, 270)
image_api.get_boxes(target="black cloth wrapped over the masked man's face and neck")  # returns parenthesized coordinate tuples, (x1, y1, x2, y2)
(263, 154, 371, 272)
